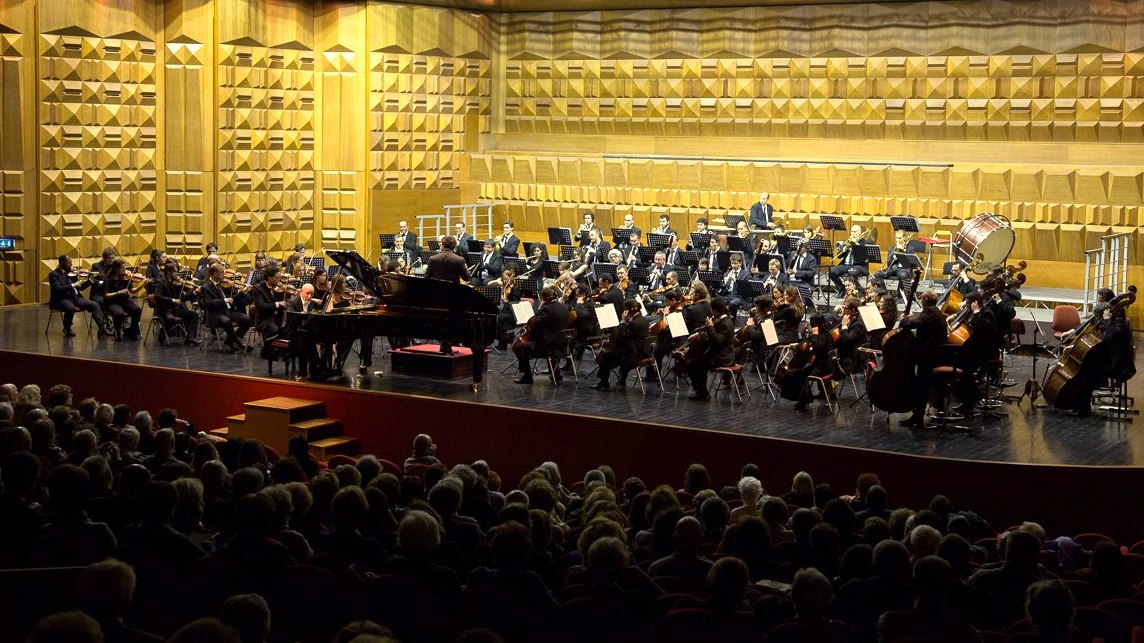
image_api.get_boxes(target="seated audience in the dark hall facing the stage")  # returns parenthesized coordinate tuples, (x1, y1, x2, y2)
(0, 375, 1142, 643)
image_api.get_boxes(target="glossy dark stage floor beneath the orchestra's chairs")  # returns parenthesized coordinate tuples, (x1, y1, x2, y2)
(0, 305, 1144, 467)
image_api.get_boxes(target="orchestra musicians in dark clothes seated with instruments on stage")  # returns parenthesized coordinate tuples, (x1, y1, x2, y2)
(35, 210, 1135, 421)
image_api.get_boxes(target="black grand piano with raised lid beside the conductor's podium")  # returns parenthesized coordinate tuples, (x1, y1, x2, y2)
(283, 251, 496, 391)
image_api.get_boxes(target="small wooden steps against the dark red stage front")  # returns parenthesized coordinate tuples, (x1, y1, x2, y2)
(207, 397, 362, 461)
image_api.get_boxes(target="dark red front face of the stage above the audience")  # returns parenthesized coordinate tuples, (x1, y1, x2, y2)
(0, 351, 1144, 542)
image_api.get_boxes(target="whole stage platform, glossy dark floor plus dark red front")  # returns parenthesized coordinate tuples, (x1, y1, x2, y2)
(0, 305, 1144, 538)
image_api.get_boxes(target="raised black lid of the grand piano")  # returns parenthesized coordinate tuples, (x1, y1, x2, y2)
(326, 251, 496, 315)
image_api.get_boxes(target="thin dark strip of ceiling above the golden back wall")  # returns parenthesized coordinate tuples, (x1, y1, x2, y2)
(406, 0, 916, 13)
